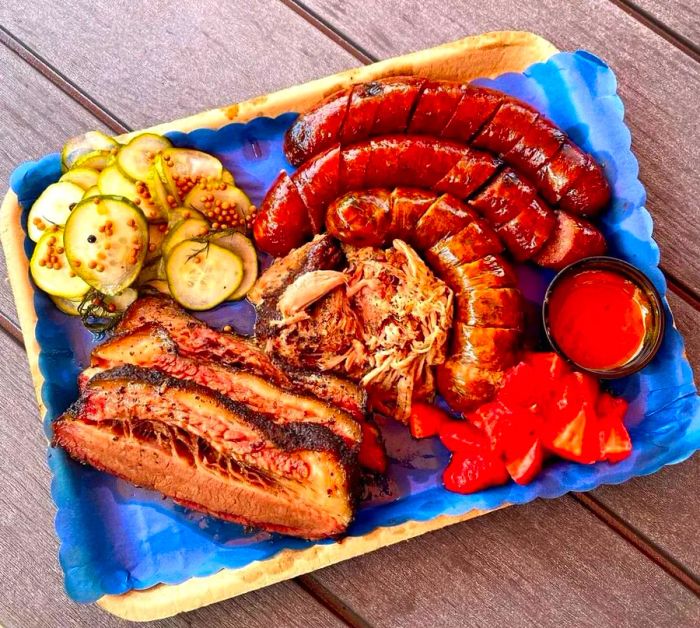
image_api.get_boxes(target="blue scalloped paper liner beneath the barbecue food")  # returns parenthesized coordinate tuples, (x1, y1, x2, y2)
(5, 46, 700, 602)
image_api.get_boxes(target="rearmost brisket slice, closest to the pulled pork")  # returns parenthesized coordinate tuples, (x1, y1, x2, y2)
(117, 296, 366, 420)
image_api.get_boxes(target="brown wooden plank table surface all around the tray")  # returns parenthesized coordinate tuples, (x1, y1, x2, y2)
(0, 0, 700, 628)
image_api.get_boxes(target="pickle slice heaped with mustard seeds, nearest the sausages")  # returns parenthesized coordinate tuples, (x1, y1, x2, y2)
(184, 180, 252, 231)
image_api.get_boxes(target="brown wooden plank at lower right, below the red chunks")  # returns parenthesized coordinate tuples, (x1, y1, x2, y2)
(316, 498, 700, 627)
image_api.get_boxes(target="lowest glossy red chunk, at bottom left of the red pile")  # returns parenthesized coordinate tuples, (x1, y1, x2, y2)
(442, 447, 508, 493)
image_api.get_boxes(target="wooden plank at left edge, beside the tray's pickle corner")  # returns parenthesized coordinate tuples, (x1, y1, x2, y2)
(0, 45, 105, 326)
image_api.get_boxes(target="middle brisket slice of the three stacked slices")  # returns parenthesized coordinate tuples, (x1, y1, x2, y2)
(80, 323, 362, 449)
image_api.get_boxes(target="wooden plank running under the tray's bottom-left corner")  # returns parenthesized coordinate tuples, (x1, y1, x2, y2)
(0, 334, 343, 628)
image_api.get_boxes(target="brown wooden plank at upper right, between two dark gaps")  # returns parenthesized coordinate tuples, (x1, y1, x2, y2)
(305, 0, 700, 287)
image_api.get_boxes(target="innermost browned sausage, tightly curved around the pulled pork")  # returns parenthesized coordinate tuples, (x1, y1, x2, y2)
(326, 187, 523, 411)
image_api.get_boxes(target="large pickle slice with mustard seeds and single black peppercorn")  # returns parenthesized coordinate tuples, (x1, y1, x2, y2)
(64, 196, 148, 296)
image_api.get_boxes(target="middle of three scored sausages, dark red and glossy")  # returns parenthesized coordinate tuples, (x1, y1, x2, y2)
(253, 135, 605, 269)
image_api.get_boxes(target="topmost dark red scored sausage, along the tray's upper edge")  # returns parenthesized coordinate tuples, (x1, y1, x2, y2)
(285, 77, 610, 215)
